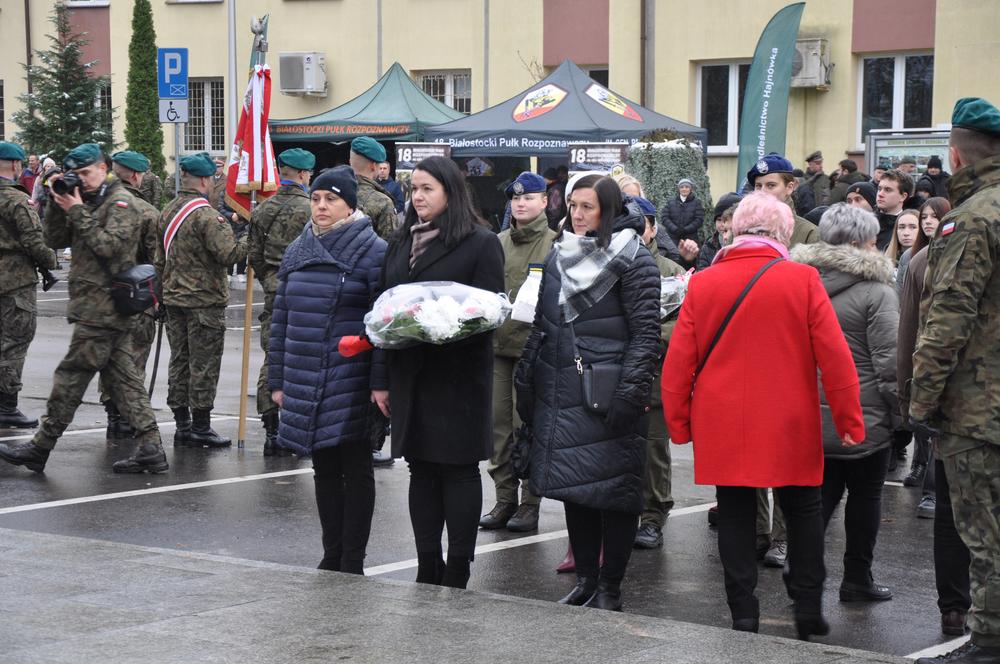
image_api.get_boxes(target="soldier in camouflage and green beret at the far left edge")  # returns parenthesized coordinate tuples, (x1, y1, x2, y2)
(0, 142, 57, 428)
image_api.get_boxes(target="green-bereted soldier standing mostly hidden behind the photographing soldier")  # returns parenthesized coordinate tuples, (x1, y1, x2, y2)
(100, 150, 160, 440)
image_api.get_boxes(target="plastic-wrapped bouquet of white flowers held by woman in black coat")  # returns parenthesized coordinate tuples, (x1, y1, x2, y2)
(365, 281, 511, 349)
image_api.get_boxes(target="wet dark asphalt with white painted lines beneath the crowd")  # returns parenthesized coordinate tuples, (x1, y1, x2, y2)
(0, 274, 968, 655)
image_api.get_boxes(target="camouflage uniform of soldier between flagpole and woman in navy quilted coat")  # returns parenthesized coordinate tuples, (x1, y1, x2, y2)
(248, 184, 312, 415)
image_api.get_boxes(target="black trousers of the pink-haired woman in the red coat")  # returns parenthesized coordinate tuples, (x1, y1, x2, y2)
(720, 486, 826, 620)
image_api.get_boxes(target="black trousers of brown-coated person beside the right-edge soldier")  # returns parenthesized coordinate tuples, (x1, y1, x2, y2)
(934, 459, 972, 613)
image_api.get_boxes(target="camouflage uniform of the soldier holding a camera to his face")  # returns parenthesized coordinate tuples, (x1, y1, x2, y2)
(32, 176, 160, 450)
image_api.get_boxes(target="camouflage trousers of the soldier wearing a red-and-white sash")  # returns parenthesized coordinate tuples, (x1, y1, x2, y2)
(167, 306, 226, 410)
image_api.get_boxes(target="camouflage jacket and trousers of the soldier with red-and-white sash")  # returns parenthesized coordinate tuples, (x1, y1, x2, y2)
(156, 189, 247, 410)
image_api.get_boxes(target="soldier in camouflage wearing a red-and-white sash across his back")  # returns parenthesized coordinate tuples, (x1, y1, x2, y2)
(156, 152, 247, 447)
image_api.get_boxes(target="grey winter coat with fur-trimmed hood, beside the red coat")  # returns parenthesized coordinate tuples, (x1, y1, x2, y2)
(792, 242, 899, 459)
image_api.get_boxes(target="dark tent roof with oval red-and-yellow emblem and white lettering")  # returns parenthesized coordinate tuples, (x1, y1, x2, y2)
(424, 60, 708, 156)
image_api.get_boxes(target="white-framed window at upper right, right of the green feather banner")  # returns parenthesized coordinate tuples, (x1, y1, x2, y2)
(858, 55, 934, 145)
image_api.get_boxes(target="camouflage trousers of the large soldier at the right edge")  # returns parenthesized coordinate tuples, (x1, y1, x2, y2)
(938, 433, 1000, 647)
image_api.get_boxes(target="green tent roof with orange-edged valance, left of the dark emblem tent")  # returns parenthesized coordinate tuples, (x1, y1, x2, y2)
(268, 62, 465, 143)
